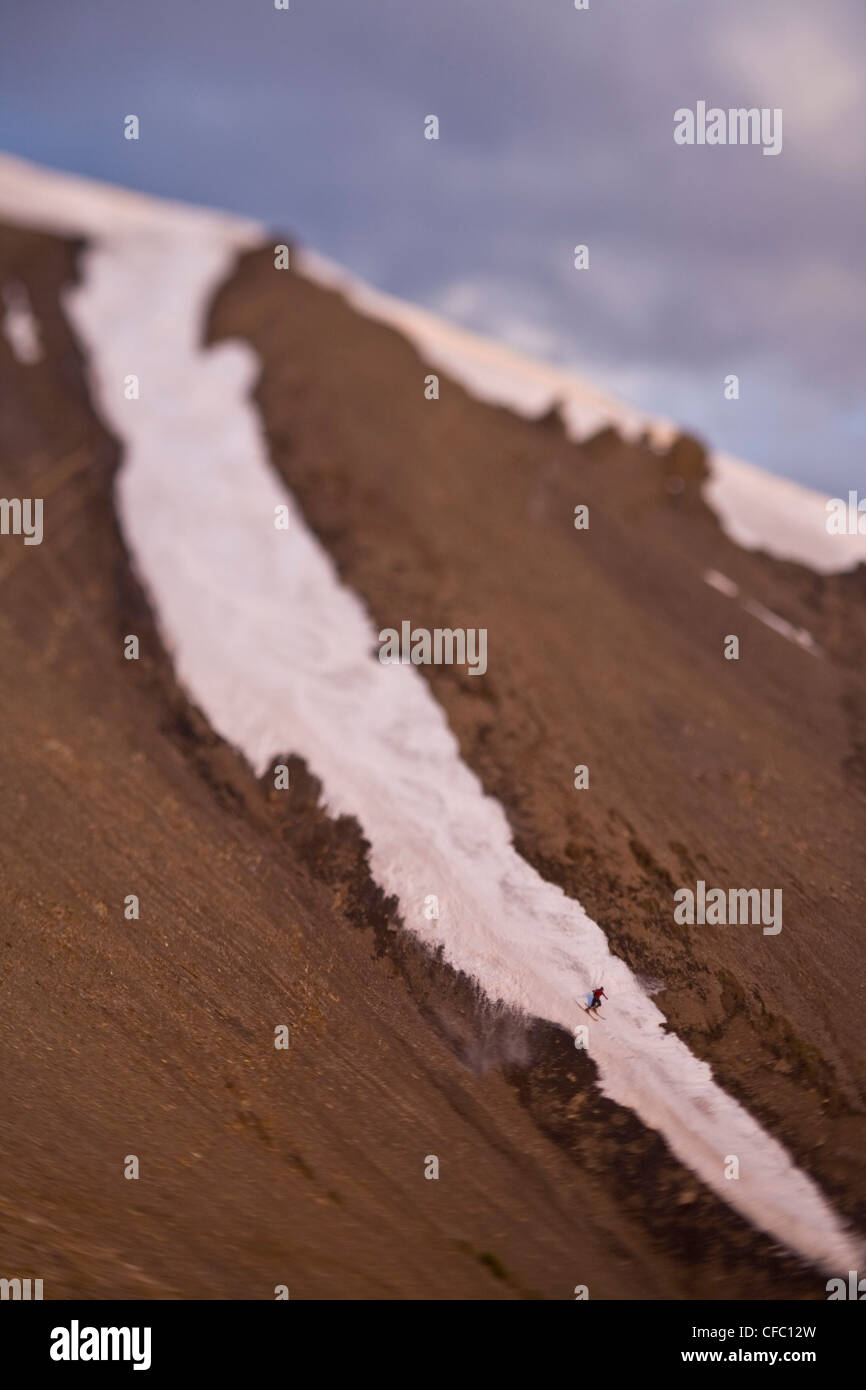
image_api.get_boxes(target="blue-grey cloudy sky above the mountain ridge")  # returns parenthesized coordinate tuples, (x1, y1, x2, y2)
(0, 0, 866, 493)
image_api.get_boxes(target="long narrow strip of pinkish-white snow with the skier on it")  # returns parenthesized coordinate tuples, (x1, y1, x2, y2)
(0, 149, 858, 1273)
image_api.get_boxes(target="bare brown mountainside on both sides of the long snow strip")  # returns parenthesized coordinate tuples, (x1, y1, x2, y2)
(3, 157, 862, 1297)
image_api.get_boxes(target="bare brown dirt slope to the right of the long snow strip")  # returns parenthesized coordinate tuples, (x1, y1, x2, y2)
(210, 250, 866, 1225)
